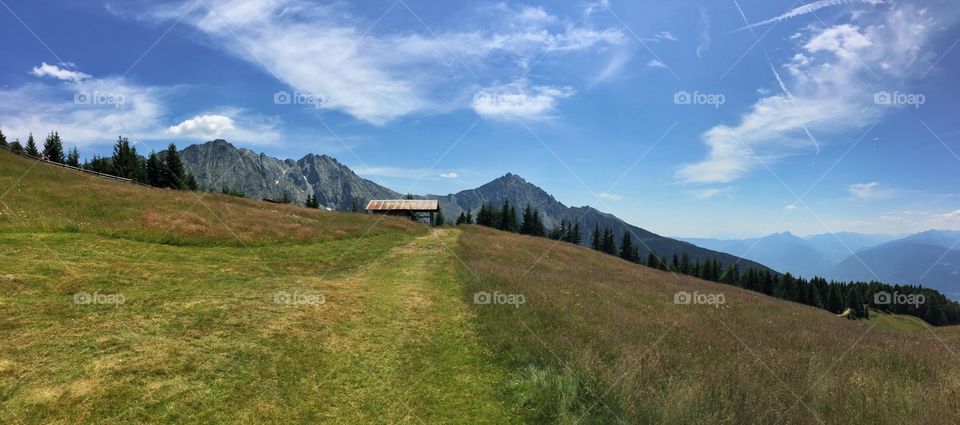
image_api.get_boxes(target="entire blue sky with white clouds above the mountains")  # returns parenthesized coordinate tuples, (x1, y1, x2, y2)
(0, 0, 960, 237)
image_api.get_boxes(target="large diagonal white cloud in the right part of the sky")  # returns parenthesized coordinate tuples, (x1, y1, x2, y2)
(674, 5, 933, 183)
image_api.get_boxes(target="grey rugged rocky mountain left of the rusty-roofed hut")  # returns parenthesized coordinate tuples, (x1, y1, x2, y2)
(180, 139, 401, 210)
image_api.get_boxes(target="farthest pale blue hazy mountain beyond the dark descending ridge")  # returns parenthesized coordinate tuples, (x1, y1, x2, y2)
(681, 232, 835, 278)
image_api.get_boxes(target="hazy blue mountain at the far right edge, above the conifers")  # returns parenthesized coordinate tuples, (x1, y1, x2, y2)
(831, 230, 960, 299)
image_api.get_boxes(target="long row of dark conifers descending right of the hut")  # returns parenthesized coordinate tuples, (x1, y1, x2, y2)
(456, 200, 960, 326)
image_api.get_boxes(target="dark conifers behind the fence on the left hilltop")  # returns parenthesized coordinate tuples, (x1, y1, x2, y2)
(0, 130, 197, 190)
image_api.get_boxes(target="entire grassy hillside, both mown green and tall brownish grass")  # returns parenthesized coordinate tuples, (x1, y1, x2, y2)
(0, 147, 960, 424)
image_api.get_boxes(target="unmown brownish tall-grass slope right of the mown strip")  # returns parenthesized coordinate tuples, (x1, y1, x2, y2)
(458, 227, 960, 424)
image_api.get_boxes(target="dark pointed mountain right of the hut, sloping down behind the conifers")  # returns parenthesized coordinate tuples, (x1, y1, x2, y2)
(427, 173, 776, 270)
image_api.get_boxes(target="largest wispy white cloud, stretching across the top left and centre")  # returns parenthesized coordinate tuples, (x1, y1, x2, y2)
(154, 0, 627, 125)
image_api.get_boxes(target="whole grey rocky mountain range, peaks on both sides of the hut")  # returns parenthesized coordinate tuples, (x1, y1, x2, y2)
(181, 139, 775, 270)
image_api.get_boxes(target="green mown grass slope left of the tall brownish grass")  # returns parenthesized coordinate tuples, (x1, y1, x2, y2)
(0, 152, 512, 423)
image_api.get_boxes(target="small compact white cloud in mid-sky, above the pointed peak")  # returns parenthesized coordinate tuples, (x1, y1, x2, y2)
(472, 79, 574, 120)
